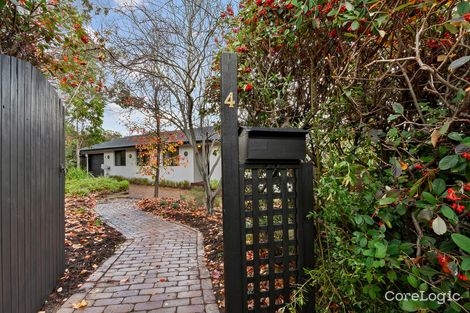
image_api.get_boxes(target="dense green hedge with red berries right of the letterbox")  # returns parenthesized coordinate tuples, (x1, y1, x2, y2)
(218, 0, 470, 312)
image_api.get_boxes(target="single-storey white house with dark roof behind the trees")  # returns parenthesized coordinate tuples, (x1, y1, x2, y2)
(80, 127, 222, 183)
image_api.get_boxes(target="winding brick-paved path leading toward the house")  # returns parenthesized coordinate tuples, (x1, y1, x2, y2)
(57, 199, 219, 313)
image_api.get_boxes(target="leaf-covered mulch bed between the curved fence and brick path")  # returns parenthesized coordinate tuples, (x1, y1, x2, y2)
(42, 195, 125, 313)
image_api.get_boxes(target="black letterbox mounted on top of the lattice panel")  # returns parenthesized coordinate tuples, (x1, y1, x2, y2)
(238, 127, 307, 163)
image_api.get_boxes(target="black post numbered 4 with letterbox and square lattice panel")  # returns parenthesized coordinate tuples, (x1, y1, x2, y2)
(221, 53, 314, 313)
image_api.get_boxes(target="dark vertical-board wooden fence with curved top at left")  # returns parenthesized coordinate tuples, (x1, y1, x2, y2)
(0, 56, 65, 313)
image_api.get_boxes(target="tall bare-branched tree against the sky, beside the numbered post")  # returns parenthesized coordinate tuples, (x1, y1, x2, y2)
(106, 0, 220, 213)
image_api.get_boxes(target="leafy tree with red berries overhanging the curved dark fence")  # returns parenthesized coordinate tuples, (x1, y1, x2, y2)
(0, 0, 105, 166)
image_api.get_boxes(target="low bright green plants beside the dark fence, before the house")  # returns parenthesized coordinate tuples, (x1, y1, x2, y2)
(65, 169, 129, 196)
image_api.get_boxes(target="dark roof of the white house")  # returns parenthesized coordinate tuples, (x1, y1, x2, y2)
(80, 127, 220, 153)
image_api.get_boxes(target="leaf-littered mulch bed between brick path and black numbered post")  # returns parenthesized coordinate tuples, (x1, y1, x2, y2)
(137, 198, 225, 312)
